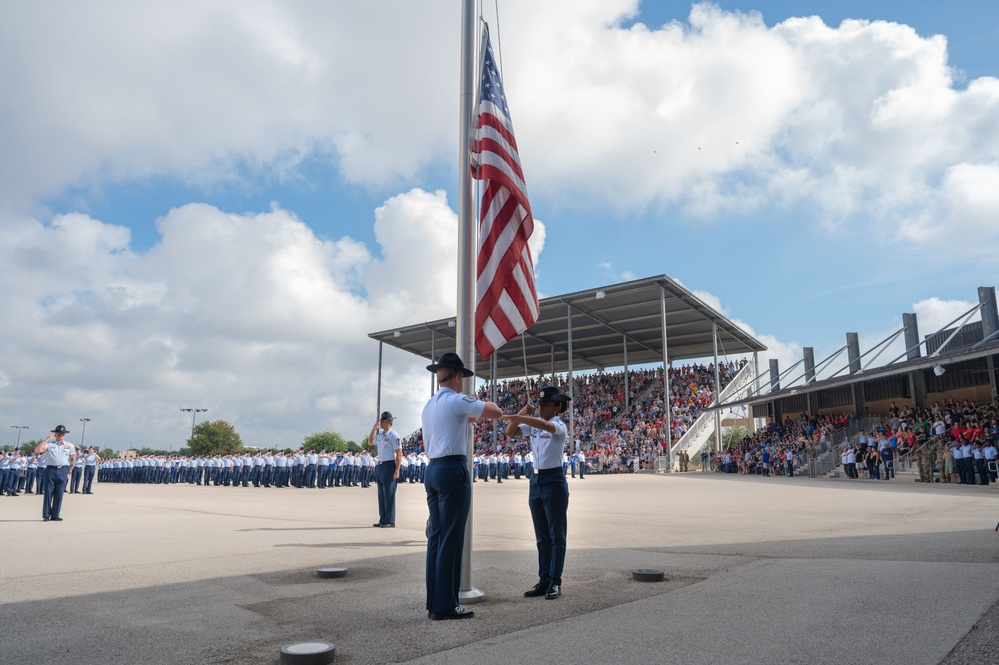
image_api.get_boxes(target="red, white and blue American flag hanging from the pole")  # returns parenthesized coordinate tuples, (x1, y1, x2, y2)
(471, 27, 538, 358)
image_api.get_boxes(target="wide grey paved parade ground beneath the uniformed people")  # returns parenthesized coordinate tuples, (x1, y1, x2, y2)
(0, 473, 999, 665)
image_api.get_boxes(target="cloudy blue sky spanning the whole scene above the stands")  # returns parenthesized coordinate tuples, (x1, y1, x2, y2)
(0, 0, 999, 447)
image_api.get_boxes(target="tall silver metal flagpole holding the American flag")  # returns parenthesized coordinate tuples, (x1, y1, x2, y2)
(455, 0, 486, 603)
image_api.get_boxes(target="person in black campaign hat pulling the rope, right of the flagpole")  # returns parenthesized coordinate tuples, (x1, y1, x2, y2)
(504, 386, 571, 600)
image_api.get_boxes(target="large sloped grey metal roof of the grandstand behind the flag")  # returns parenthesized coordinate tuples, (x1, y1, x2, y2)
(369, 275, 766, 379)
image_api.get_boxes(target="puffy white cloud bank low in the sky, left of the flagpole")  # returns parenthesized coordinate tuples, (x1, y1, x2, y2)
(0, 190, 472, 447)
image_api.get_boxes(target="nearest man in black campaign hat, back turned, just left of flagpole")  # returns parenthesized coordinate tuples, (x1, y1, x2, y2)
(423, 353, 503, 621)
